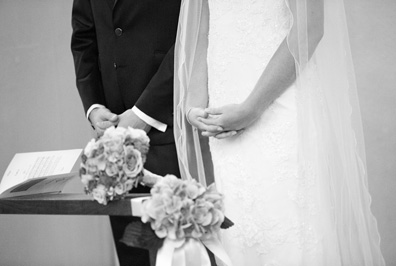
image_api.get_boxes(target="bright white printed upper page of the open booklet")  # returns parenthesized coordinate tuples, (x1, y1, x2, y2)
(0, 149, 82, 194)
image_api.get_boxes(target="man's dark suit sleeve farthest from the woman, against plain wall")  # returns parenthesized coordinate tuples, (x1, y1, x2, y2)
(71, 0, 106, 112)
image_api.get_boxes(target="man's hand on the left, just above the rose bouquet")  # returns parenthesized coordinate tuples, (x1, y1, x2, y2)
(88, 107, 119, 137)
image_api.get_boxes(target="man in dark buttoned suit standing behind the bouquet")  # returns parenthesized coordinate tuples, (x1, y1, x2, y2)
(71, 0, 180, 266)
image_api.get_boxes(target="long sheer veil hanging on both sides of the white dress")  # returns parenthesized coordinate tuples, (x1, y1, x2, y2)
(174, 0, 385, 266)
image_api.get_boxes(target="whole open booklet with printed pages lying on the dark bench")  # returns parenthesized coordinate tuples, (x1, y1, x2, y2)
(0, 149, 82, 198)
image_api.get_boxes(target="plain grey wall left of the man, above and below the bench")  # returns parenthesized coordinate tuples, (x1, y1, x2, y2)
(0, 0, 114, 266)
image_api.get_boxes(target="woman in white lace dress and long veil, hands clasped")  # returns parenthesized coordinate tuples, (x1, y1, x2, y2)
(175, 0, 384, 266)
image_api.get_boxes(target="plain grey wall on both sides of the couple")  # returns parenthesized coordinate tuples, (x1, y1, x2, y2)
(0, 0, 396, 266)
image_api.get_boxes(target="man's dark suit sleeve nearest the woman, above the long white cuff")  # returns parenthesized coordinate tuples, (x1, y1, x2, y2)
(135, 46, 174, 126)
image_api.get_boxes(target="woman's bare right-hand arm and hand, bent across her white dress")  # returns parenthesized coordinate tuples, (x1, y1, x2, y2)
(200, 0, 324, 136)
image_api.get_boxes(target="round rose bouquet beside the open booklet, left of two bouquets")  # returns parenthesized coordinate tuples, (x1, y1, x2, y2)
(80, 127, 150, 205)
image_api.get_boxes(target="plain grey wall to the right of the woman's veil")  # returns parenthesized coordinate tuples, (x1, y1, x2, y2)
(344, 0, 396, 266)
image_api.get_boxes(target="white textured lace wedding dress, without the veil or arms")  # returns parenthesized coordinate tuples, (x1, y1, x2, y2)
(207, 0, 312, 266)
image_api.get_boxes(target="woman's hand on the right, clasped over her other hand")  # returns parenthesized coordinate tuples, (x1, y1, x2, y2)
(197, 104, 259, 138)
